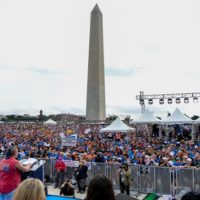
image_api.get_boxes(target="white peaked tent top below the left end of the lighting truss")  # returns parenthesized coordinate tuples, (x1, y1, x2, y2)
(130, 109, 161, 124)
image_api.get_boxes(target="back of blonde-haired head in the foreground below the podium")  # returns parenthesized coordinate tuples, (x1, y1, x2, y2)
(13, 178, 46, 200)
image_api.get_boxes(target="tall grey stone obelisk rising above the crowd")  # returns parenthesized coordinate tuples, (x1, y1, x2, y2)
(86, 4, 106, 121)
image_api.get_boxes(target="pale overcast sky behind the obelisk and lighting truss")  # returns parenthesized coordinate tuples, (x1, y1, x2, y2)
(0, 0, 200, 118)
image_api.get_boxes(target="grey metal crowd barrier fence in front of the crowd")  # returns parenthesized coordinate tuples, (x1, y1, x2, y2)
(40, 159, 200, 195)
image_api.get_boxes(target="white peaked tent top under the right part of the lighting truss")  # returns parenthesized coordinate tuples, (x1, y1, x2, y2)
(162, 108, 194, 124)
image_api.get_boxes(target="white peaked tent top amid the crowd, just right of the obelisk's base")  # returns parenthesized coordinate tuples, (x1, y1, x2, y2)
(100, 117, 135, 132)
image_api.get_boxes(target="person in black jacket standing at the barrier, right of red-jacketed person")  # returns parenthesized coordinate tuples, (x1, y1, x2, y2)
(76, 160, 88, 193)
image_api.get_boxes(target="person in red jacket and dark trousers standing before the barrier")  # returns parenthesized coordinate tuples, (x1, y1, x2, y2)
(54, 156, 66, 188)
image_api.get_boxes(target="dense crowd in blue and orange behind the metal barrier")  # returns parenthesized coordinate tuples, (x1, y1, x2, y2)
(0, 124, 200, 167)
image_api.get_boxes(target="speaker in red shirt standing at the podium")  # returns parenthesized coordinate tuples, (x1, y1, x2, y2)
(0, 147, 32, 200)
